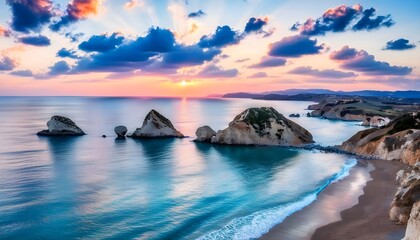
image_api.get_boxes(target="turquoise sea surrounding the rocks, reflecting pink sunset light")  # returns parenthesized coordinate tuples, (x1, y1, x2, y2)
(0, 97, 363, 239)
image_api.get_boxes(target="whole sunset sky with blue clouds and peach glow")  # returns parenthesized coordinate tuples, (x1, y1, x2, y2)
(0, 0, 420, 97)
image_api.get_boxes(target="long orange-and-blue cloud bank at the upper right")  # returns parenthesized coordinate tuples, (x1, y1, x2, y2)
(290, 4, 394, 36)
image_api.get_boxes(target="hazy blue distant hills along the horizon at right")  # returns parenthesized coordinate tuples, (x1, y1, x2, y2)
(223, 89, 420, 100)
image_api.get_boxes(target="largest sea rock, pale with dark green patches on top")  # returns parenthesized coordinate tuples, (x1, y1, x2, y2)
(211, 107, 314, 146)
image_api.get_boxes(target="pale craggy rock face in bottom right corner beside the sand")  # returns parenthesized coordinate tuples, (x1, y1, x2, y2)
(389, 162, 420, 240)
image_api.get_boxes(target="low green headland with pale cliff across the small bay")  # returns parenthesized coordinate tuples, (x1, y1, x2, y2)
(308, 98, 401, 124)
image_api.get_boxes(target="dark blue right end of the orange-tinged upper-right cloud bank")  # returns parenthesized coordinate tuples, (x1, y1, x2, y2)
(353, 8, 395, 31)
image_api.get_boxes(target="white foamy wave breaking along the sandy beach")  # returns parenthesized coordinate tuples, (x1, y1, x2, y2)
(198, 158, 357, 240)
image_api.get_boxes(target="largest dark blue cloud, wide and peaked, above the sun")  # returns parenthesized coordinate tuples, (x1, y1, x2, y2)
(69, 28, 221, 74)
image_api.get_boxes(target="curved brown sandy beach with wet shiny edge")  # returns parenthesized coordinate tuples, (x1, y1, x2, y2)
(259, 159, 405, 240)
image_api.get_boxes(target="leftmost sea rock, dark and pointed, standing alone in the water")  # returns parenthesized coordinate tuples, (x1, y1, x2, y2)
(37, 116, 86, 136)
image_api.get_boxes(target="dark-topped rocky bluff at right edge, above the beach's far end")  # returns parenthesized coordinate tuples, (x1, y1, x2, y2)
(341, 113, 420, 165)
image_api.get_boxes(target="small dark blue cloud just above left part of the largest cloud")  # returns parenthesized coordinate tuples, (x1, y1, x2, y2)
(79, 33, 124, 52)
